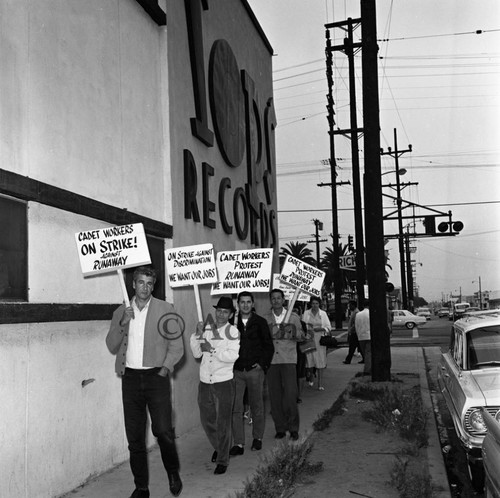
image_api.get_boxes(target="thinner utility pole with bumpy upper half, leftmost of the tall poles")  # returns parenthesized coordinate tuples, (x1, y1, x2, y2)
(325, 30, 344, 329)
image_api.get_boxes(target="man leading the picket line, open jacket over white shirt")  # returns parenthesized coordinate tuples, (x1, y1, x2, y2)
(106, 266, 184, 498)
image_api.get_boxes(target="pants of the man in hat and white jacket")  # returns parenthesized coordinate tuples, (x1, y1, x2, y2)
(198, 379, 234, 466)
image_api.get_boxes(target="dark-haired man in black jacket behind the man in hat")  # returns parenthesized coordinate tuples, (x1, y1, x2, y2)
(229, 291, 274, 456)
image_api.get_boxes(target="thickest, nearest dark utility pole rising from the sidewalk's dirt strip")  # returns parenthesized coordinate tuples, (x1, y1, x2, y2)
(361, 0, 391, 382)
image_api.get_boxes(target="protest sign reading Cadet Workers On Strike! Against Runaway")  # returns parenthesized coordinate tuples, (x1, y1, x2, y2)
(75, 223, 151, 277)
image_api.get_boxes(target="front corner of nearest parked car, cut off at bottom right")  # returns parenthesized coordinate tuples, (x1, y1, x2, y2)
(481, 408, 500, 498)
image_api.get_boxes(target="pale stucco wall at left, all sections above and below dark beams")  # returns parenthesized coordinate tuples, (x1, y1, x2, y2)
(0, 0, 174, 498)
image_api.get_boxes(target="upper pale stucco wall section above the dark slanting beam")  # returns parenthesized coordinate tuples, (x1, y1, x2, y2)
(0, 0, 170, 221)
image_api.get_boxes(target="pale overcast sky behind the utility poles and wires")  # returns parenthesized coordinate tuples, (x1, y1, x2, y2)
(248, 0, 500, 302)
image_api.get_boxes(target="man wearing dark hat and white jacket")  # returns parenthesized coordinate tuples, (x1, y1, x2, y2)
(190, 296, 240, 474)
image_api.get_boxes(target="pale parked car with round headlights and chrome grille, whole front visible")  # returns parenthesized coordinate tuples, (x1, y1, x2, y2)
(437, 310, 500, 492)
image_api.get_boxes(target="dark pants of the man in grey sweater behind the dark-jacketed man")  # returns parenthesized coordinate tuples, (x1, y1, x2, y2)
(267, 363, 299, 432)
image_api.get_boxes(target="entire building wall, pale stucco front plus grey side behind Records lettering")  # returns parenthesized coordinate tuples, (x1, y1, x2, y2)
(0, 0, 277, 498)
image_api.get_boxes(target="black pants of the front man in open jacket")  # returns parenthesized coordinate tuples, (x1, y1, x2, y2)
(122, 368, 179, 488)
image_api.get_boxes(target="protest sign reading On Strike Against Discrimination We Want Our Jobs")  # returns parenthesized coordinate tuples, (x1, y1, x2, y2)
(165, 244, 217, 287)
